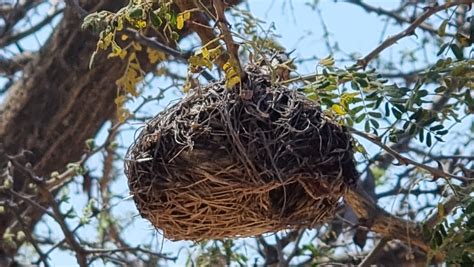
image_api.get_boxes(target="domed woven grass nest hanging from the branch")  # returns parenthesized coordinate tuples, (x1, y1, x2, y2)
(125, 67, 358, 241)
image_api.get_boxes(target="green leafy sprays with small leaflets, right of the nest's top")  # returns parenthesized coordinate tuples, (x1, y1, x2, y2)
(304, 57, 474, 151)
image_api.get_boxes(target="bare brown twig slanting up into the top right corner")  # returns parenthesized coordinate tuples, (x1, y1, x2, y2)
(357, 0, 472, 69)
